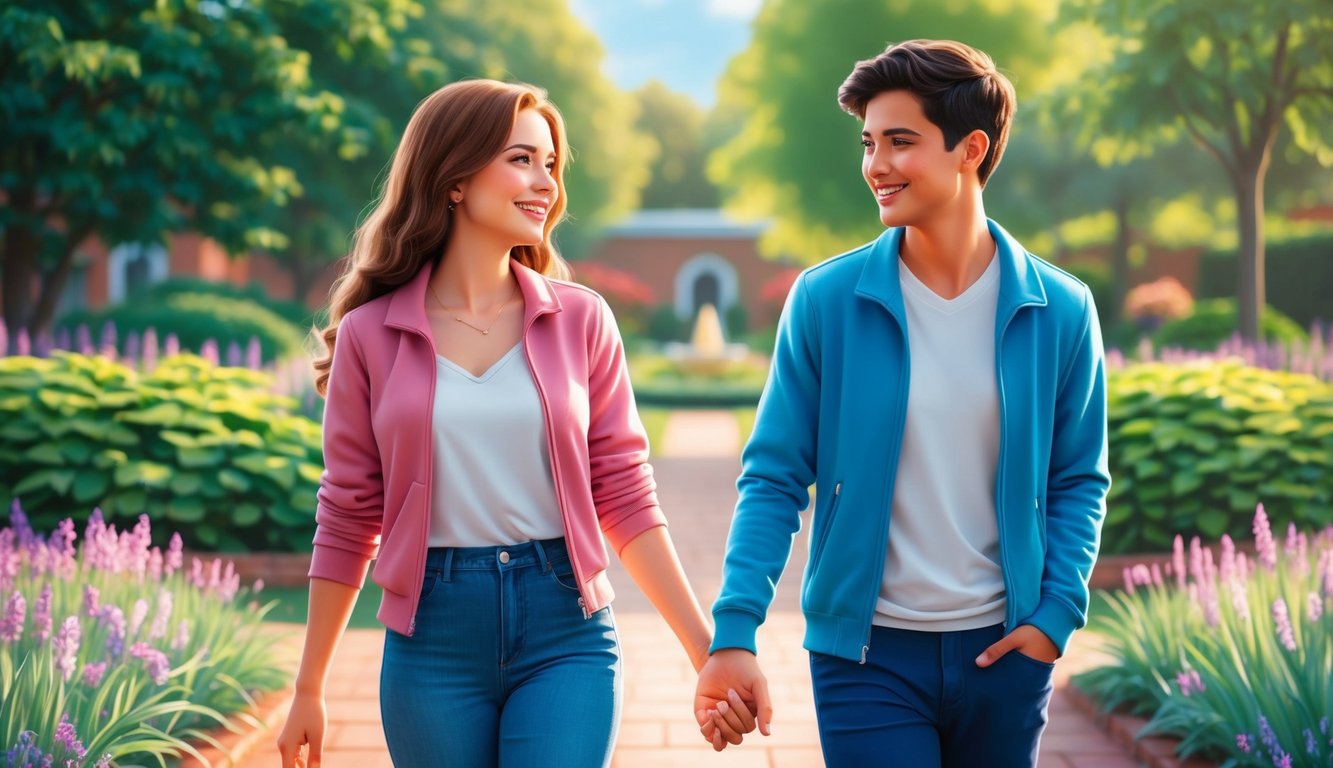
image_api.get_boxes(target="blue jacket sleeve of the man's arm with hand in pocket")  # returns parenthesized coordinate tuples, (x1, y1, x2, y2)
(1022, 288, 1110, 653)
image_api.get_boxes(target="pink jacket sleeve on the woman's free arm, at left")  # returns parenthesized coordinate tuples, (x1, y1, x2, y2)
(309, 321, 384, 588)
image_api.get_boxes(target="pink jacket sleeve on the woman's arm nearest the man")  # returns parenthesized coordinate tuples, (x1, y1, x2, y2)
(588, 297, 667, 555)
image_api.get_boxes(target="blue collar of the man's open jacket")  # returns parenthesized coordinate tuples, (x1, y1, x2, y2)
(856, 219, 1046, 321)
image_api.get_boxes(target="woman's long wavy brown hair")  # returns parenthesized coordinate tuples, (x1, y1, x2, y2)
(315, 80, 569, 395)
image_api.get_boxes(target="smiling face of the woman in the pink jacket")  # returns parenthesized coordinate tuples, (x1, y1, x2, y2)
(455, 109, 560, 247)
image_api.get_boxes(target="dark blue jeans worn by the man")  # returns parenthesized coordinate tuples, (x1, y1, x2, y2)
(810, 624, 1054, 768)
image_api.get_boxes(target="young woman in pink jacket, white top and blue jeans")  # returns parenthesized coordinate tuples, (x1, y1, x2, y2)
(279, 80, 710, 768)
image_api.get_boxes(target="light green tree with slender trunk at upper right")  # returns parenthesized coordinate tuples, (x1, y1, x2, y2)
(1065, 0, 1333, 339)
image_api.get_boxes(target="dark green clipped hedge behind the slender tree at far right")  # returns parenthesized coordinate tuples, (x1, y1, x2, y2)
(1198, 235, 1333, 328)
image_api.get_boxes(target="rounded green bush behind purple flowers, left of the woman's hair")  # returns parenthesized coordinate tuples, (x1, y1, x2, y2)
(57, 291, 304, 363)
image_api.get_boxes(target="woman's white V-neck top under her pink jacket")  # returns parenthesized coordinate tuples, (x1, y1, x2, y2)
(428, 341, 565, 547)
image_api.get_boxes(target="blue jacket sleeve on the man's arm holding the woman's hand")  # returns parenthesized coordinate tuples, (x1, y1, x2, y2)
(710, 275, 820, 652)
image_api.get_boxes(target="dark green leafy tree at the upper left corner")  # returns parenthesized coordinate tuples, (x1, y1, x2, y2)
(0, 0, 375, 341)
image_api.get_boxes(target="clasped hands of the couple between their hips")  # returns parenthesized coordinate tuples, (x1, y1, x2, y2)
(694, 648, 773, 752)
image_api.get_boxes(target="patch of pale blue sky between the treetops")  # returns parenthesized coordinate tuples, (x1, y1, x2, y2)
(569, 0, 761, 108)
